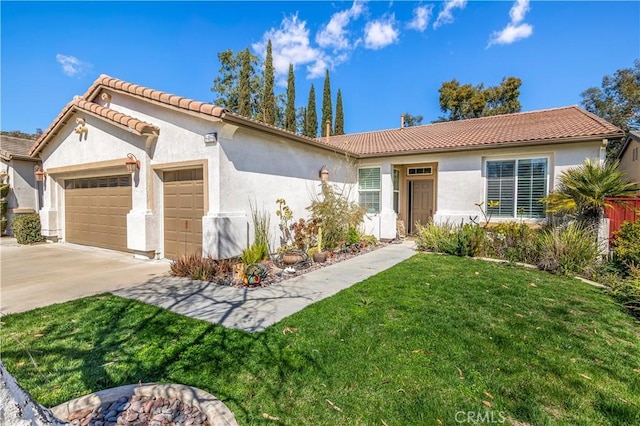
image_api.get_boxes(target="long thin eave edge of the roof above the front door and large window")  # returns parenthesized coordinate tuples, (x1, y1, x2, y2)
(360, 133, 623, 158)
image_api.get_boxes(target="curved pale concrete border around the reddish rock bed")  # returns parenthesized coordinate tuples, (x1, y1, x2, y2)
(51, 383, 238, 426)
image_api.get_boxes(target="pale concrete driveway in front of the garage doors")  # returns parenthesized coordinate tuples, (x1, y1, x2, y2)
(0, 237, 169, 314)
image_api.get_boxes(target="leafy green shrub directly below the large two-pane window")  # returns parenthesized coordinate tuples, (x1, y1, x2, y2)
(484, 221, 541, 264)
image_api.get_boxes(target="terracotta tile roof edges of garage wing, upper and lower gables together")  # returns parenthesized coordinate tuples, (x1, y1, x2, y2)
(30, 74, 346, 155)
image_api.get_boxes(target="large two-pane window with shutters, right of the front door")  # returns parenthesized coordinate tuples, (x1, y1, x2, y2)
(487, 158, 547, 218)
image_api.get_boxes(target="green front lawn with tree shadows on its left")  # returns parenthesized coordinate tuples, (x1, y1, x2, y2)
(0, 254, 640, 426)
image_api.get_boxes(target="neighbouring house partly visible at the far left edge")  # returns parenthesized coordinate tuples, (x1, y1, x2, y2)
(0, 135, 40, 235)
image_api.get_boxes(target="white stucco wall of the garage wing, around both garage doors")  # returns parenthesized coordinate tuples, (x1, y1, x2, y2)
(36, 93, 354, 258)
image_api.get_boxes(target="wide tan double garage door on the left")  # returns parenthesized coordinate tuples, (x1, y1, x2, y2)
(64, 175, 131, 250)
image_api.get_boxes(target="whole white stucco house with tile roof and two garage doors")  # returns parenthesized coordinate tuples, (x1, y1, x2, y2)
(30, 75, 622, 258)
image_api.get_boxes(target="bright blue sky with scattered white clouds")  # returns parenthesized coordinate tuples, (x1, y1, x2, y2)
(0, 0, 640, 133)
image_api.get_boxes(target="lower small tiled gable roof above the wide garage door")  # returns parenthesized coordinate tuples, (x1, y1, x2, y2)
(30, 98, 160, 155)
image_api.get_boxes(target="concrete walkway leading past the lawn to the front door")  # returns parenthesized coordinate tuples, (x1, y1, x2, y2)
(112, 241, 415, 331)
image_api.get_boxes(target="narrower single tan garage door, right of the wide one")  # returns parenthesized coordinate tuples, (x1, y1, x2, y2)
(163, 169, 204, 259)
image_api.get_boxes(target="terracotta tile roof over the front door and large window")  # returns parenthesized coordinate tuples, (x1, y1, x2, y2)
(317, 105, 623, 157)
